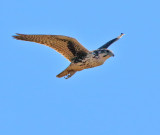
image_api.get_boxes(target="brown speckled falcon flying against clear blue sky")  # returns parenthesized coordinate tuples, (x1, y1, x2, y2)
(13, 33, 124, 79)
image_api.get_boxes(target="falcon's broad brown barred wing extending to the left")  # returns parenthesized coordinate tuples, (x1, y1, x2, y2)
(13, 34, 89, 61)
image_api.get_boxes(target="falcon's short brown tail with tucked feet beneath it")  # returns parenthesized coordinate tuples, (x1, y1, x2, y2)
(56, 69, 77, 79)
